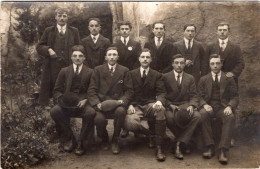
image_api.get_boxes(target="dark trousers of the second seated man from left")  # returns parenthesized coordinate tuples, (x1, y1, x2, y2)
(94, 106, 126, 143)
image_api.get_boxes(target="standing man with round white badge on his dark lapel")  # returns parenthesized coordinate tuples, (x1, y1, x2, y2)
(114, 21, 141, 70)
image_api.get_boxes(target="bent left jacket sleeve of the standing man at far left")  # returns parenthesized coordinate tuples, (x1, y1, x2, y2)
(36, 28, 50, 57)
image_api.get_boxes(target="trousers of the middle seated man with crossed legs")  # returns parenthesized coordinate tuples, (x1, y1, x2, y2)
(125, 103, 166, 145)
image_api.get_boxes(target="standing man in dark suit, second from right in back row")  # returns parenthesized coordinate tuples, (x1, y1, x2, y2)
(173, 24, 208, 84)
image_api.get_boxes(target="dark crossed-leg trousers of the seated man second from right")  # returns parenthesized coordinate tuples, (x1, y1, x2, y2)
(166, 104, 201, 144)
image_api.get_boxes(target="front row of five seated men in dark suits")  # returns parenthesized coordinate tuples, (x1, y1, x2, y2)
(51, 45, 238, 164)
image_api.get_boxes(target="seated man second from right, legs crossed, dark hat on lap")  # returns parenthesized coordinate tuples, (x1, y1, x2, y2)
(164, 54, 201, 160)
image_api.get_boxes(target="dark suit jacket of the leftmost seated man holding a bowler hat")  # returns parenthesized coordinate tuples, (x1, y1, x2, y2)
(54, 65, 93, 100)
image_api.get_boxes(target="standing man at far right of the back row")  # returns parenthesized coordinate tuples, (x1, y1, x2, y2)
(206, 22, 245, 86)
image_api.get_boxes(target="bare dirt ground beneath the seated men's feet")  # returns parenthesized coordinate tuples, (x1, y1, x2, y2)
(32, 119, 260, 169)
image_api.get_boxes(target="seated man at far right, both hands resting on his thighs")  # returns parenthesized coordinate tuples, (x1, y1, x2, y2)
(198, 54, 238, 164)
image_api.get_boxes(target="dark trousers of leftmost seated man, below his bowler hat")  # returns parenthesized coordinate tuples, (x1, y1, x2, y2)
(50, 105, 96, 143)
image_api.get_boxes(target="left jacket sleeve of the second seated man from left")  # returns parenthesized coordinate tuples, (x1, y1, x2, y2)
(87, 69, 100, 106)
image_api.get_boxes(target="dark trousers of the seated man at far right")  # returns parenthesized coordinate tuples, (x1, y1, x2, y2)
(200, 106, 235, 149)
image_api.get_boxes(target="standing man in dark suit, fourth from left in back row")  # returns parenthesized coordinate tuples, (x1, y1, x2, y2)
(144, 22, 177, 73)
